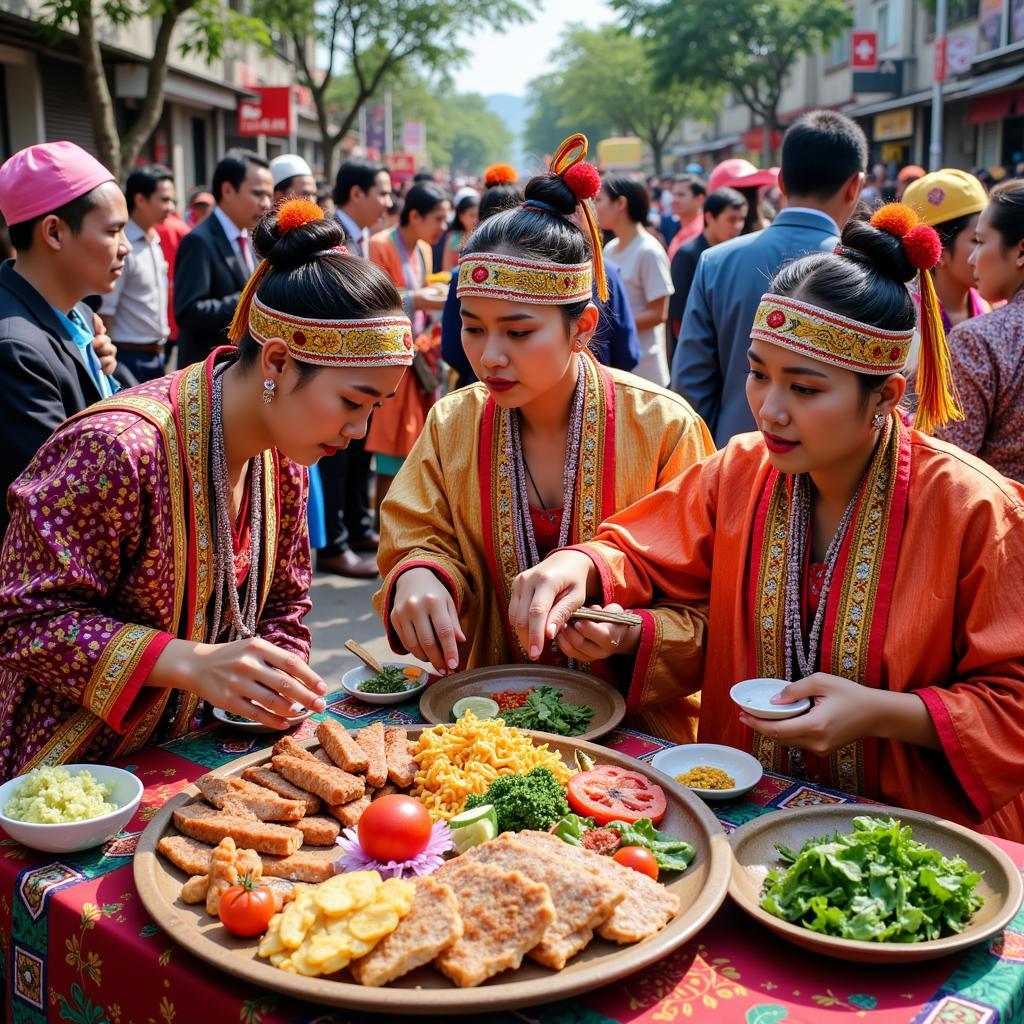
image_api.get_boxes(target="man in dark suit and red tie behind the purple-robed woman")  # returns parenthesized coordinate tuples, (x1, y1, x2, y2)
(174, 150, 273, 367)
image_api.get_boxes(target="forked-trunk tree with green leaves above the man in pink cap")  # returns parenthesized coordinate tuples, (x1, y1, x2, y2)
(40, 0, 269, 180)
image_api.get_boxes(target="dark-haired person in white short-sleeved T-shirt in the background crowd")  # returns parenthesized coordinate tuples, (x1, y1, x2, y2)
(595, 174, 672, 387)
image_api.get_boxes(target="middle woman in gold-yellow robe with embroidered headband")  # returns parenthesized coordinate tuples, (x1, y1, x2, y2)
(375, 140, 713, 737)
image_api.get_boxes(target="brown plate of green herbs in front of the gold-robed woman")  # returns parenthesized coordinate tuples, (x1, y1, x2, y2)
(420, 665, 626, 740)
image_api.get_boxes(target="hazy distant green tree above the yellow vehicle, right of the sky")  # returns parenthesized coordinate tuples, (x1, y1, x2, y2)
(526, 25, 715, 173)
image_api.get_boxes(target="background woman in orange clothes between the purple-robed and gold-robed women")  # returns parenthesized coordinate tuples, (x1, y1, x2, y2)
(367, 181, 452, 508)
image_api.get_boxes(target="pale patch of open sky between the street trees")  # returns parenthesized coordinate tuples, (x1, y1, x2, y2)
(455, 0, 613, 96)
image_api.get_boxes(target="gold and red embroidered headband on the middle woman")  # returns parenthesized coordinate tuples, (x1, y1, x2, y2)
(456, 253, 594, 305)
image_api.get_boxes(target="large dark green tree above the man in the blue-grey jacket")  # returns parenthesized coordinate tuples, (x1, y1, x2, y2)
(610, 0, 853, 158)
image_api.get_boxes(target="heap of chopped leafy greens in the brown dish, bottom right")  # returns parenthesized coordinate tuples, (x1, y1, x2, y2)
(761, 815, 984, 942)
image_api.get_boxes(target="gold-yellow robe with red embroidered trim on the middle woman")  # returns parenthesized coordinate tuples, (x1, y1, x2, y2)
(374, 358, 714, 739)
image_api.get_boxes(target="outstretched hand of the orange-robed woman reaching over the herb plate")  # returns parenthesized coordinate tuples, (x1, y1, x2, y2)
(509, 551, 597, 662)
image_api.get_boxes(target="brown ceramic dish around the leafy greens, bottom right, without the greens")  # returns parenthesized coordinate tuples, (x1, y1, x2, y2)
(729, 804, 1024, 964)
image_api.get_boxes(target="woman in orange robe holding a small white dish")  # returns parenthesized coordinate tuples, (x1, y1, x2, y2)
(509, 201, 1024, 840)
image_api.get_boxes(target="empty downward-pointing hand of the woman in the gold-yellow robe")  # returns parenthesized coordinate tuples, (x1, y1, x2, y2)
(391, 566, 466, 675)
